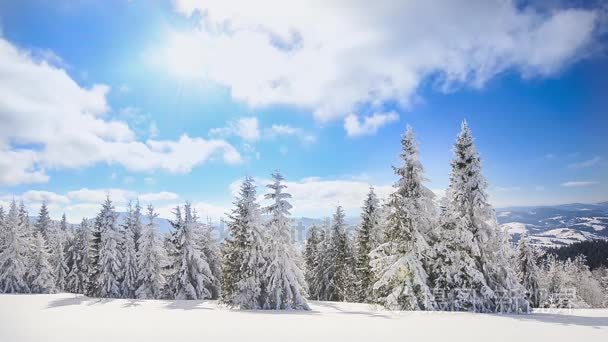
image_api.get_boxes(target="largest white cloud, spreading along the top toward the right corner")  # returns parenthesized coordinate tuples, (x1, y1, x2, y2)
(164, 0, 600, 133)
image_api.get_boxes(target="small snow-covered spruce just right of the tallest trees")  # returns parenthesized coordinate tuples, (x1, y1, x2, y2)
(516, 232, 541, 308)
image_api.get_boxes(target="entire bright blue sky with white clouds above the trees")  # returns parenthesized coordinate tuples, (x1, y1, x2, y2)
(0, 0, 608, 222)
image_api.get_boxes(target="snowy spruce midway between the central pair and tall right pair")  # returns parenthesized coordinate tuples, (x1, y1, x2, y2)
(323, 206, 356, 302)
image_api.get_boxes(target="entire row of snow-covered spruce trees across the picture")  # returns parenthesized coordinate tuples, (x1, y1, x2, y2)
(0, 122, 608, 312)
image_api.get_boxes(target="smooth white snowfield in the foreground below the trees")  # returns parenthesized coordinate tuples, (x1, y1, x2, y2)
(0, 294, 608, 342)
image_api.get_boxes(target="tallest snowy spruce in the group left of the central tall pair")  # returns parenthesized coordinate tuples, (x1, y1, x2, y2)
(91, 196, 122, 298)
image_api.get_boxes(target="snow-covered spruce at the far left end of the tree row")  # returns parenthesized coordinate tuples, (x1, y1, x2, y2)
(0, 200, 30, 293)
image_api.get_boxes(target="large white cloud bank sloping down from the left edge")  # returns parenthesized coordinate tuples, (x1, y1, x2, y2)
(0, 37, 241, 185)
